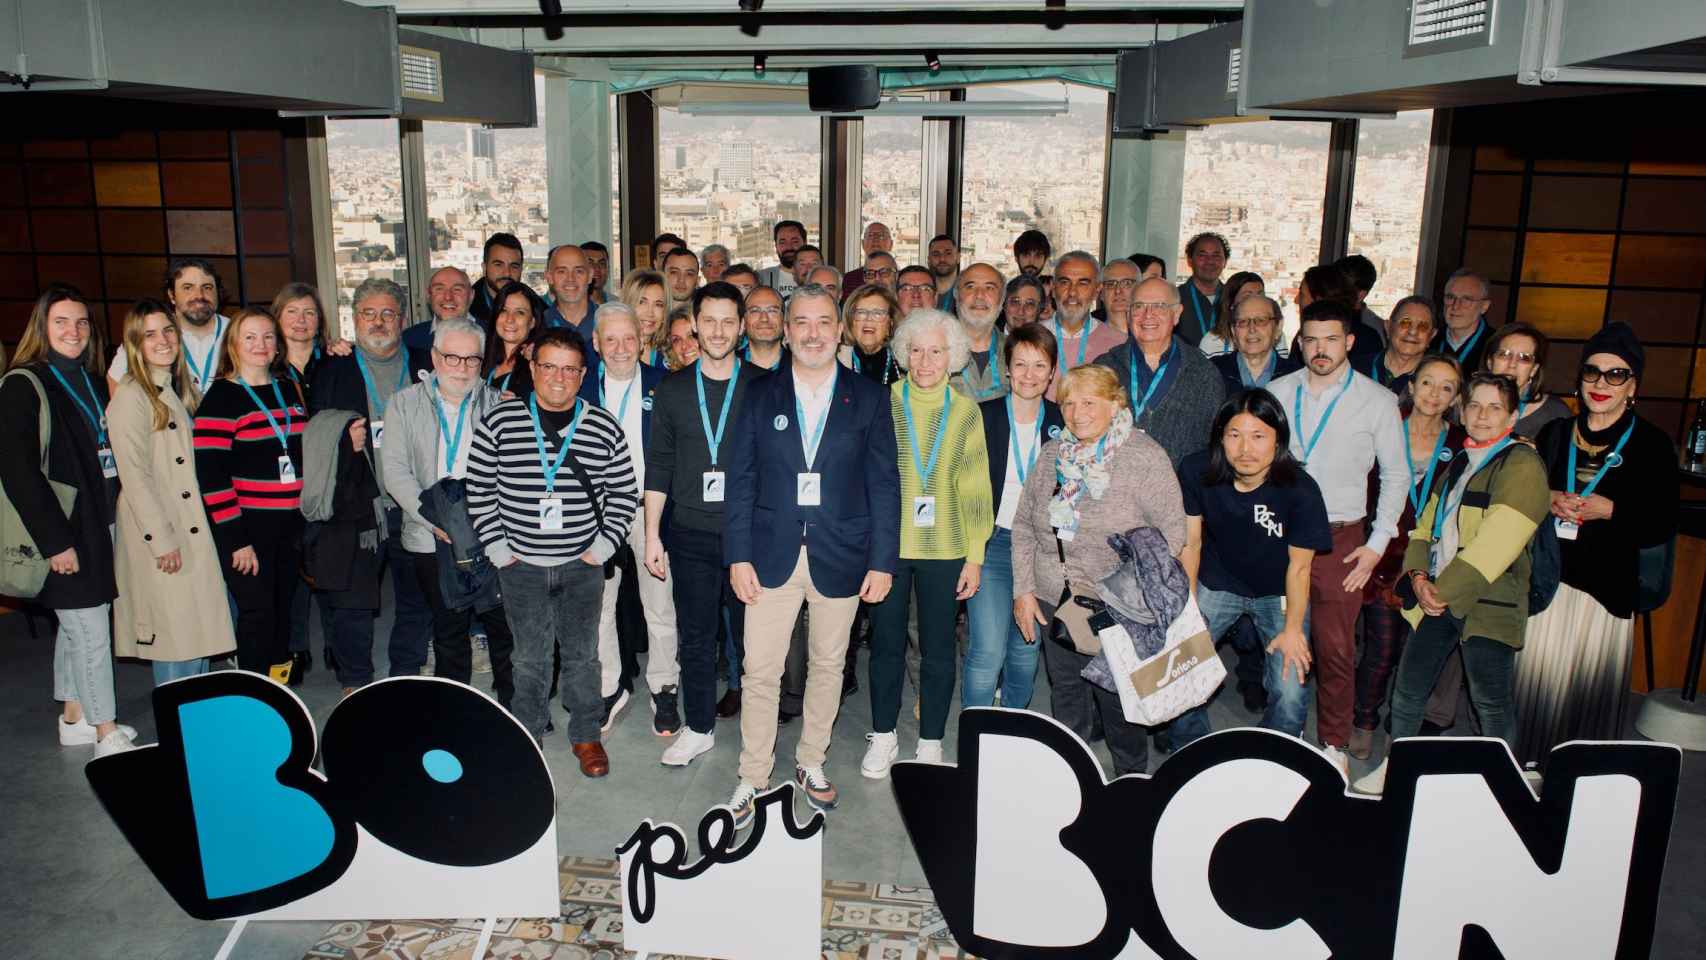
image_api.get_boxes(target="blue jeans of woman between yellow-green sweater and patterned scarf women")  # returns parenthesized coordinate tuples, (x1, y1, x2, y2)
(960, 527, 1042, 709)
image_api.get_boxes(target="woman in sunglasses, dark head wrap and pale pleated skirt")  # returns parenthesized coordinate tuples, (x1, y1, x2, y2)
(1521, 322, 1677, 764)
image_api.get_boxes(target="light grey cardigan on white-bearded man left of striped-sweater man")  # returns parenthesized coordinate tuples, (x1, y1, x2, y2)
(379, 377, 503, 554)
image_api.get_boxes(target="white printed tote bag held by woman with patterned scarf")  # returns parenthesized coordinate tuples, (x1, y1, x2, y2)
(1099, 597, 1227, 726)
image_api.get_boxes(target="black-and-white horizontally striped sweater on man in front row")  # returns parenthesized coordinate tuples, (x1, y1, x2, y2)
(467, 399, 640, 566)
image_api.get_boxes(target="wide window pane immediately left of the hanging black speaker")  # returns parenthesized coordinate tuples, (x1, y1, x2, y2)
(651, 107, 822, 269)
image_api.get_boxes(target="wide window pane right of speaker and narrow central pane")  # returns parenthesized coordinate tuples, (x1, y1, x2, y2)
(960, 82, 1105, 276)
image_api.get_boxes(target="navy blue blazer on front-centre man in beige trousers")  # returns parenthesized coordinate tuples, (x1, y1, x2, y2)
(723, 370, 901, 597)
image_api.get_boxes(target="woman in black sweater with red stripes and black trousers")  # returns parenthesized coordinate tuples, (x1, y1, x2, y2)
(184, 307, 317, 684)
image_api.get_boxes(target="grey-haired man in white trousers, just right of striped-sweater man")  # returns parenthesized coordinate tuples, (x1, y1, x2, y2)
(580, 300, 681, 737)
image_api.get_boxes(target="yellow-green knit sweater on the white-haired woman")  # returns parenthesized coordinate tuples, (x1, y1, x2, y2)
(889, 380, 995, 564)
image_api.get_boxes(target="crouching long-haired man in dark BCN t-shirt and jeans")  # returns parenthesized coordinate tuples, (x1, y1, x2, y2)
(1179, 389, 1332, 745)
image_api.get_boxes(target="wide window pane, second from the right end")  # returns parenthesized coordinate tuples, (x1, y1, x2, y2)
(1169, 119, 1331, 343)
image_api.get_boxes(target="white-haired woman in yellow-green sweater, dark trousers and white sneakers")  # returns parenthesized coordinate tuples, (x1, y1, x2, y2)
(860, 309, 995, 779)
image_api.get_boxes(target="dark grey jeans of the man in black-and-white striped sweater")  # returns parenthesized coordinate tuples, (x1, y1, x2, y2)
(498, 559, 604, 743)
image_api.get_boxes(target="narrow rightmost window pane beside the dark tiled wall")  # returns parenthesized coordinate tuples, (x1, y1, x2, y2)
(1346, 111, 1433, 317)
